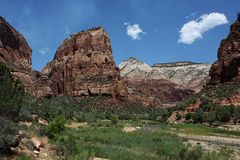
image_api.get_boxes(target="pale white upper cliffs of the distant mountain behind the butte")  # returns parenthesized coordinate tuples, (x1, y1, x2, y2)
(119, 58, 211, 92)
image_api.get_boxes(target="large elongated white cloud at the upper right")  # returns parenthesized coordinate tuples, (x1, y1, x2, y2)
(178, 12, 228, 44)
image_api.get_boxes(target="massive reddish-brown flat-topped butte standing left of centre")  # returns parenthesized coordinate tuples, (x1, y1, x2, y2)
(42, 27, 125, 99)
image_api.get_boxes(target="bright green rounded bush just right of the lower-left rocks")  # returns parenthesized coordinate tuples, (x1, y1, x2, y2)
(47, 116, 66, 139)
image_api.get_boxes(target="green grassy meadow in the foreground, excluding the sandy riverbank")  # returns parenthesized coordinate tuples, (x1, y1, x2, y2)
(47, 121, 236, 160)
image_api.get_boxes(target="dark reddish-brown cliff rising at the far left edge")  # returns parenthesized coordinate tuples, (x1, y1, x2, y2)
(0, 17, 33, 90)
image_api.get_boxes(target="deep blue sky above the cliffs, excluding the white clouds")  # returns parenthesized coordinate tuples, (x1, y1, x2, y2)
(0, 0, 240, 70)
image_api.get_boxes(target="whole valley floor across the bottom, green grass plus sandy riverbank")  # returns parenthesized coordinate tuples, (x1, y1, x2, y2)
(13, 120, 240, 160)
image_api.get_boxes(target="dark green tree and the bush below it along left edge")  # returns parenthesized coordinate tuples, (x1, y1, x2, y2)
(0, 63, 24, 151)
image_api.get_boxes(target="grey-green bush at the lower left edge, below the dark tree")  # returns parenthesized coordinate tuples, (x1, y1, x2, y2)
(0, 117, 20, 150)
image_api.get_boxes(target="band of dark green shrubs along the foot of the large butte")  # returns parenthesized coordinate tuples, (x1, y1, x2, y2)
(20, 96, 165, 122)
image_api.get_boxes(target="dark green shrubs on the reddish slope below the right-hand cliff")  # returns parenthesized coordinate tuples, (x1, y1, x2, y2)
(175, 83, 240, 125)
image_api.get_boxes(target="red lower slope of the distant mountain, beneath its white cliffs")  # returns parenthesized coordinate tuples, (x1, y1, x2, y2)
(126, 78, 194, 108)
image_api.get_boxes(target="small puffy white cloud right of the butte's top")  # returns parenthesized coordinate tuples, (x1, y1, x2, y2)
(124, 22, 146, 40)
